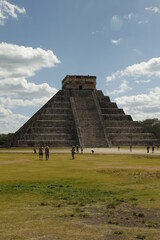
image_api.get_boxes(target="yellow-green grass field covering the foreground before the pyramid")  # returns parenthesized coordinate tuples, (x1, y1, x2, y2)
(0, 151, 160, 240)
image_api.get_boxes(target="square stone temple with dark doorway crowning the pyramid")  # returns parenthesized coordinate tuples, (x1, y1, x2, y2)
(62, 75, 96, 90)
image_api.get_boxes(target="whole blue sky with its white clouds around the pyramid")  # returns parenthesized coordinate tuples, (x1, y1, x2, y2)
(0, 0, 160, 133)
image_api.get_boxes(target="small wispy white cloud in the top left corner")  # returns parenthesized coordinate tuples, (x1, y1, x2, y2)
(0, 0, 26, 26)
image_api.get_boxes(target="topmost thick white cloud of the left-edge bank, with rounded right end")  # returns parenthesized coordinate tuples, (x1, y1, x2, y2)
(0, 43, 60, 79)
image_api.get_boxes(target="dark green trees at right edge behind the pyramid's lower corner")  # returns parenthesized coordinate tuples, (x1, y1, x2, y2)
(140, 118, 160, 139)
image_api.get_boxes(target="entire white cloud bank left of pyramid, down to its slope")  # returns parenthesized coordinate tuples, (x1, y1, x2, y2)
(0, 43, 60, 132)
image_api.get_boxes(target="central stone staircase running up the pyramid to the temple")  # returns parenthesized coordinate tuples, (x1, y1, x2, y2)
(69, 90, 108, 147)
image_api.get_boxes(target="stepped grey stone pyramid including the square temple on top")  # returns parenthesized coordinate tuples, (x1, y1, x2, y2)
(12, 75, 157, 147)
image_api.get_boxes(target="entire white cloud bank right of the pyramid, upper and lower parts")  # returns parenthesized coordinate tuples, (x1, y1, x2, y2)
(106, 58, 160, 120)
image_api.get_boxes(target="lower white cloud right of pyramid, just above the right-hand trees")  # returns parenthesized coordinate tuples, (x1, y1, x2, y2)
(114, 87, 160, 120)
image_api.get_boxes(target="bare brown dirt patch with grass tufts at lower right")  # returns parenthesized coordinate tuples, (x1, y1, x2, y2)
(84, 204, 160, 229)
